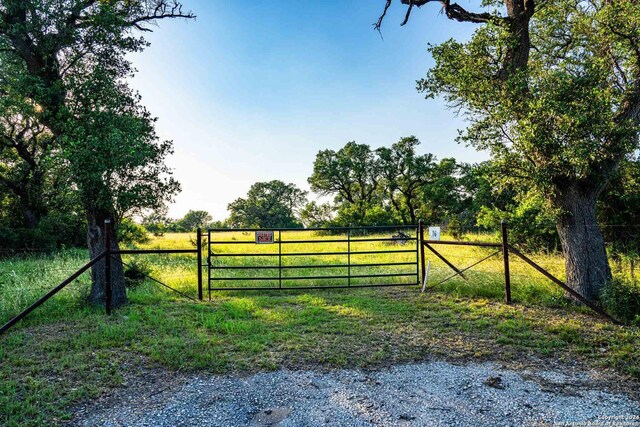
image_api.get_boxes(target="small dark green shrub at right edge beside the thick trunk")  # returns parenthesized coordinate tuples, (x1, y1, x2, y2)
(600, 279, 640, 325)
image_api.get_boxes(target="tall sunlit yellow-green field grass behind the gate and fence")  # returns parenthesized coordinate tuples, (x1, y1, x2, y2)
(0, 231, 630, 328)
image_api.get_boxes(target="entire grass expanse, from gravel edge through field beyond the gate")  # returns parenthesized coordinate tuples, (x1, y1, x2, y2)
(0, 232, 640, 426)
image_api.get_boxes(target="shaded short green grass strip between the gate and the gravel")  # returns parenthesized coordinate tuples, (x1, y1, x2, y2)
(0, 281, 640, 425)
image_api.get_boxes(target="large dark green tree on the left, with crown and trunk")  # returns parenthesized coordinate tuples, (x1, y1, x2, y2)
(0, 0, 192, 306)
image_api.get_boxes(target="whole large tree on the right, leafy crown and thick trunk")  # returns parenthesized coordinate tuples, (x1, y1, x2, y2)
(380, 0, 640, 299)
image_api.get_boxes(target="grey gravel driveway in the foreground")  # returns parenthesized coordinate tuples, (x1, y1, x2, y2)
(72, 362, 640, 427)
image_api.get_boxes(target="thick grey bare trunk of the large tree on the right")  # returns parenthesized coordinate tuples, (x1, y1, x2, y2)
(556, 185, 611, 301)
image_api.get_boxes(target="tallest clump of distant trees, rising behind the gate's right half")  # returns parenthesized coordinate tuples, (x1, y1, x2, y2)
(305, 136, 477, 226)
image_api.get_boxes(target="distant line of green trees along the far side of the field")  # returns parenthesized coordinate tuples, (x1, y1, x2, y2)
(138, 137, 640, 250)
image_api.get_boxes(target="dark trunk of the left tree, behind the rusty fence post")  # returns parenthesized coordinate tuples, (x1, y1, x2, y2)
(87, 212, 127, 308)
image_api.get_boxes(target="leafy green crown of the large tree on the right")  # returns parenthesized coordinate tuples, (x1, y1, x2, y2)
(418, 0, 640, 200)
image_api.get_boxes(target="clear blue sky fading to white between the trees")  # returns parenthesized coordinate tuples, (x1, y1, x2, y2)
(127, 0, 486, 219)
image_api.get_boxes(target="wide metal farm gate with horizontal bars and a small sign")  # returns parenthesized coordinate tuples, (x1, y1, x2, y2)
(204, 225, 420, 298)
